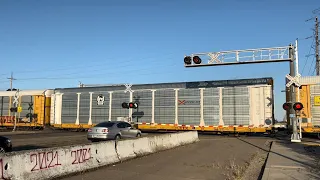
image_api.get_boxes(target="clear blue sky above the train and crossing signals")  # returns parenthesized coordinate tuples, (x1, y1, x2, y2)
(0, 0, 320, 120)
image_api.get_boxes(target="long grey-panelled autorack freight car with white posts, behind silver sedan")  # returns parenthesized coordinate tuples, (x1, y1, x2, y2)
(50, 78, 274, 133)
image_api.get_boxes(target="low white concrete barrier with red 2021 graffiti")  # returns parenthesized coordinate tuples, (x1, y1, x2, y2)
(0, 131, 199, 180)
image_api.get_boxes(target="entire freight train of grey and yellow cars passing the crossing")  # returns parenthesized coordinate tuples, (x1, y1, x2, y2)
(0, 77, 320, 137)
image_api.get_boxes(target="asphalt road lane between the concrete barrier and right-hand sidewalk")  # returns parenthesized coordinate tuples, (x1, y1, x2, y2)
(59, 135, 270, 180)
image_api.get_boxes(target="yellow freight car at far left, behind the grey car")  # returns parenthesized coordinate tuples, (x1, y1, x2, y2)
(0, 90, 53, 129)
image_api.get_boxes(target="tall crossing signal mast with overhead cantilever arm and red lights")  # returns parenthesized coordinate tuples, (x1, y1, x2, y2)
(184, 43, 303, 142)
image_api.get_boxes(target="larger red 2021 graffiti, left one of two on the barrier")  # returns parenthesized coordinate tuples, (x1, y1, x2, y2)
(30, 151, 61, 171)
